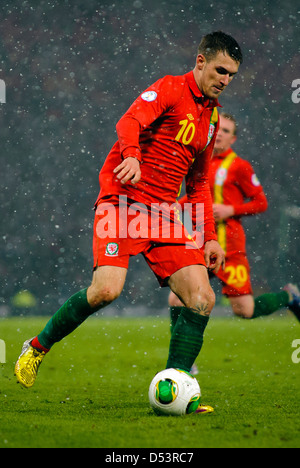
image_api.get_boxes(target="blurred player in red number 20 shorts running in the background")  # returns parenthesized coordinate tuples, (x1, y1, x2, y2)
(169, 113, 300, 322)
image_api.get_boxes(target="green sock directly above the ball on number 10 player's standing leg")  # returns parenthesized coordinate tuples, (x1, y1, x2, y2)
(166, 307, 209, 372)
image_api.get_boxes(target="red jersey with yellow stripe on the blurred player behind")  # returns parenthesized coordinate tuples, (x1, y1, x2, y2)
(209, 149, 268, 255)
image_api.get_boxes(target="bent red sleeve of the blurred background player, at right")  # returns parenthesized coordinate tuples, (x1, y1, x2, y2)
(233, 160, 268, 216)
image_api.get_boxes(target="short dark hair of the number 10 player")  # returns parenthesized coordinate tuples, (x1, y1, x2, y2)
(198, 31, 243, 63)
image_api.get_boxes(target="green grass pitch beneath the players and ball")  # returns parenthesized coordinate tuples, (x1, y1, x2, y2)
(0, 317, 300, 448)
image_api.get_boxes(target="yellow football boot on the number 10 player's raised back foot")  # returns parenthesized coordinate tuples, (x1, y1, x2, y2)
(15, 338, 46, 388)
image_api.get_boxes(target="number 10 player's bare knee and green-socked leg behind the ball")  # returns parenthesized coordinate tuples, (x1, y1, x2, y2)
(167, 265, 215, 371)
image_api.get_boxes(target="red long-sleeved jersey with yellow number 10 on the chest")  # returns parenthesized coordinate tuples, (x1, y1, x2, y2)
(96, 71, 218, 245)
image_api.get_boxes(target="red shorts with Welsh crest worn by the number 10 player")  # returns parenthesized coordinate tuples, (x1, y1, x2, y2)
(93, 197, 205, 286)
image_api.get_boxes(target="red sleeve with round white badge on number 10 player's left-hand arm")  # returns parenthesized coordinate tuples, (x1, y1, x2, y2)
(116, 75, 183, 161)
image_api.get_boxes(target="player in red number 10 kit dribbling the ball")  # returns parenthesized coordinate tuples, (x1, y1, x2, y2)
(15, 31, 242, 398)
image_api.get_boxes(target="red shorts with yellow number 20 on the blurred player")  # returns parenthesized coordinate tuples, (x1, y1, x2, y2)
(216, 253, 253, 297)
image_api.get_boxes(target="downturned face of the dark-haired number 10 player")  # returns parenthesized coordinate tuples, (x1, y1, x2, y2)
(196, 52, 239, 99)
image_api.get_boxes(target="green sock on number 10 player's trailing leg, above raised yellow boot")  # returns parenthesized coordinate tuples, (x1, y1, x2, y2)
(37, 288, 94, 349)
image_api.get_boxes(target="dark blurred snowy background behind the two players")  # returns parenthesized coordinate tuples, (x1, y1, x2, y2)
(0, 0, 300, 314)
